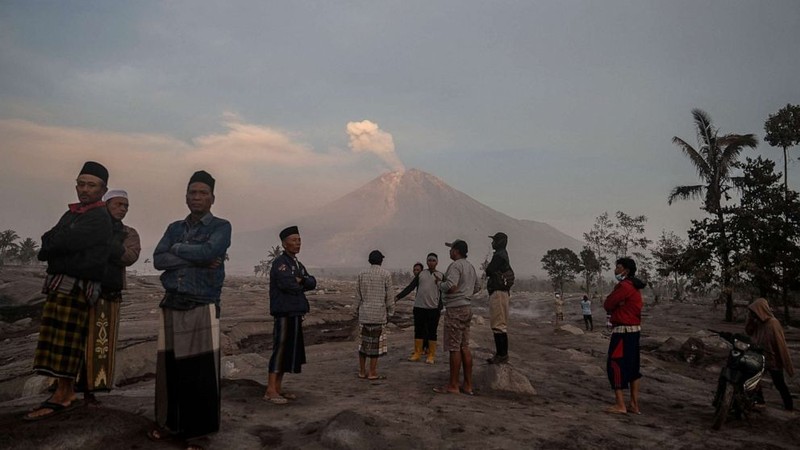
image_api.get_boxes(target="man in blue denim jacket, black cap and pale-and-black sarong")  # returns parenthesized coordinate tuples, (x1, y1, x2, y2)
(149, 170, 231, 440)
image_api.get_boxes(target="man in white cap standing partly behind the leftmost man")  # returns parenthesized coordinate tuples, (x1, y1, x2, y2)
(78, 189, 142, 402)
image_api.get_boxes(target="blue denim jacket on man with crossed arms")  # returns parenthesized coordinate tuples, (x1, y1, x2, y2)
(153, 212, 231, 304)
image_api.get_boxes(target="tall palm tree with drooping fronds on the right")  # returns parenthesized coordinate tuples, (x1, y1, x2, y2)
(668, 109, 758, 322)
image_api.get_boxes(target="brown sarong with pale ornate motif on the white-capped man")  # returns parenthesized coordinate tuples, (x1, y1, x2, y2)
(79, 296, 122, 392)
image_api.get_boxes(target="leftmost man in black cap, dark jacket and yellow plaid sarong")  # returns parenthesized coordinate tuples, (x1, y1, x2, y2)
(24, 161, 112, 420)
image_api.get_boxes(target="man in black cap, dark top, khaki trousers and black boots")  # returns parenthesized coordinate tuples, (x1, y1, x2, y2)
(486, 232, 511, 364)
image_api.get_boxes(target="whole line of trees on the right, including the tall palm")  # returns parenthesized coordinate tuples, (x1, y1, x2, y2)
(542, 105, 800, 323)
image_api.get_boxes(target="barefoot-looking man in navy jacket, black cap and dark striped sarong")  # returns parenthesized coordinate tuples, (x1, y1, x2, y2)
(264, 226, 317, 405)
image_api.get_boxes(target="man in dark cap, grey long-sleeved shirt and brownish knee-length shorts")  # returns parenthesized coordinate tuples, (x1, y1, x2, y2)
(433, 239, 481, 395)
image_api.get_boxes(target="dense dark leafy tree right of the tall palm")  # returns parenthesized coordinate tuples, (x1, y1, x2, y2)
(729, 156, 800, 323)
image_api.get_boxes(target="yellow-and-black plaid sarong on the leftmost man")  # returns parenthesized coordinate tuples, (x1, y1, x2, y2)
(33, 289, 89, 380)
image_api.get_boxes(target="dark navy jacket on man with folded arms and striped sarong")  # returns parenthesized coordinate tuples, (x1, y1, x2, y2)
(269, 252, 317, 317)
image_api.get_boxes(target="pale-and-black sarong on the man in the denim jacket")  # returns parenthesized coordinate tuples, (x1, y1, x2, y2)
(156, 304, 220, 439)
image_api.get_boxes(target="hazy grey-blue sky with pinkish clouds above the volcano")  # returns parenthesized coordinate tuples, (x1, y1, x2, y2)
(0, 0, 800, 260)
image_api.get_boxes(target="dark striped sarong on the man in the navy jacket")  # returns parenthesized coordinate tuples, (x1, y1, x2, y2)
(269, 316, 306, 373)
